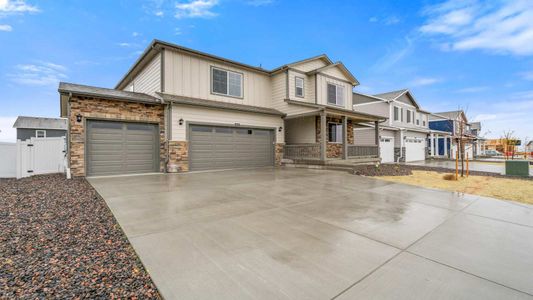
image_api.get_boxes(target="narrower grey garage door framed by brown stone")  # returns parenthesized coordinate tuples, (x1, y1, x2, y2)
(86, 120, 159, 176)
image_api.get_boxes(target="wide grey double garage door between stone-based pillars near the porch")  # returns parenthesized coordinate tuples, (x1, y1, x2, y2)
(189, 125, 274, 171)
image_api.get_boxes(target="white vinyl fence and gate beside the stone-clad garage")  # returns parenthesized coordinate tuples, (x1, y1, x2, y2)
(0, 137, 66, 178)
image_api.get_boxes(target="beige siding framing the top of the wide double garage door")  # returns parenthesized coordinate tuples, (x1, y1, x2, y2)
(172, 105, 284, 143)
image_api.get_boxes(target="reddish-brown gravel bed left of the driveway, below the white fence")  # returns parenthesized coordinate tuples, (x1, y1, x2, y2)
(0, 174, 161, 299)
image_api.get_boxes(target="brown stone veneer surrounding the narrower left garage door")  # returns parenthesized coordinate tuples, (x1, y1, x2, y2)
(68, 96, 167, 176)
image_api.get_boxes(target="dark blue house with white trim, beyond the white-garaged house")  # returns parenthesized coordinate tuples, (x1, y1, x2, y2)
(429, 110, 481, 159)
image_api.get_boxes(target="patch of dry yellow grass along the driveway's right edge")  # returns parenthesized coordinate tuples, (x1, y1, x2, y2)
(375, 170, 533, 204)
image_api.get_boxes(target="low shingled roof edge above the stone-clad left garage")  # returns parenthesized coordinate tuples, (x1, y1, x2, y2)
(58, 82, 161, 103)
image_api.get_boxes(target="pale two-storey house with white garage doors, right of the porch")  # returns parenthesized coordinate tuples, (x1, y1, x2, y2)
(352, 89, 429, 162)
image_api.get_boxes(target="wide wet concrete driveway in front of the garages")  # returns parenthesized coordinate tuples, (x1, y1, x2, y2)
(89, 169, 533, 299)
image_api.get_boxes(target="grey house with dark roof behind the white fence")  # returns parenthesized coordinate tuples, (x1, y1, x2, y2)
(13, 116, 67, 141)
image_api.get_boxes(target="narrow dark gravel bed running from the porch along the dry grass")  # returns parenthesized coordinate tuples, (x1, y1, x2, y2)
(353, 164, 533, 180)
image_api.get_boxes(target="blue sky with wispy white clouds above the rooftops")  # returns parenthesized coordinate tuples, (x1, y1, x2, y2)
(0, 0, 533, 141)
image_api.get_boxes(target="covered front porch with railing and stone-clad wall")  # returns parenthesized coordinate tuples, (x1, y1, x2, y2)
(283, 108, 380, 165)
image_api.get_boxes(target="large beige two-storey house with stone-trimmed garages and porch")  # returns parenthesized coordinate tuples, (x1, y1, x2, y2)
(59, 40, 385, 176)
